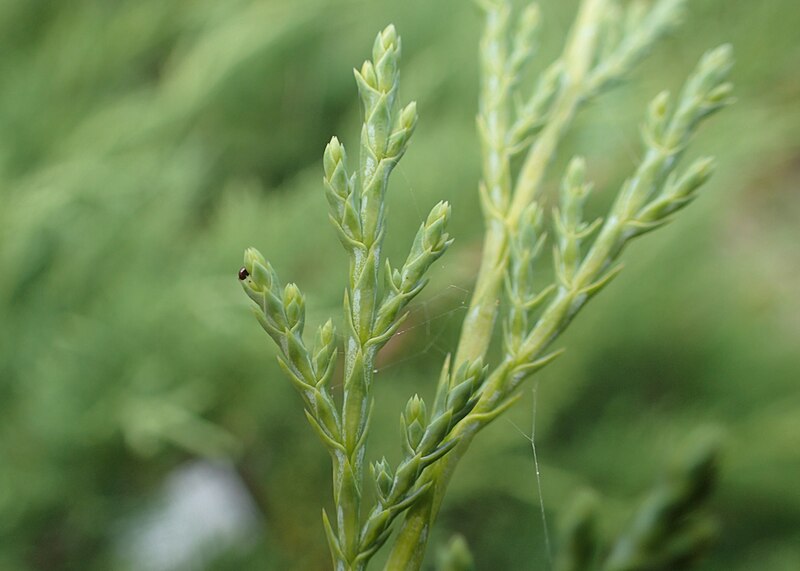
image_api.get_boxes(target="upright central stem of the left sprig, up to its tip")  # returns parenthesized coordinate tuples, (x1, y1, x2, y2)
(334, 30, 404, 571)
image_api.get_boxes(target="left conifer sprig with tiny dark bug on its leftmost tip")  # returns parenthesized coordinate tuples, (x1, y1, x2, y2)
(240, 26, 450, 571)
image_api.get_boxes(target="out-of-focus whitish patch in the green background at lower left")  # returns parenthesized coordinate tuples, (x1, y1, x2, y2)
(118, 461, 261, 571)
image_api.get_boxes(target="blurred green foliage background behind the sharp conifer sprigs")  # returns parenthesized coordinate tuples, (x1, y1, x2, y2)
(0, 0, 800, 571)
